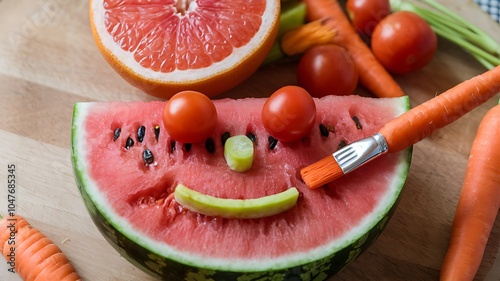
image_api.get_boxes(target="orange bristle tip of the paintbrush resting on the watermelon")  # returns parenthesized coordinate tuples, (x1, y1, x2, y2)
(300, 155, 344, 189)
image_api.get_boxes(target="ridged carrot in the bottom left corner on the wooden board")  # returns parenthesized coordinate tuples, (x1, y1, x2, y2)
(0, 215, 81, 281)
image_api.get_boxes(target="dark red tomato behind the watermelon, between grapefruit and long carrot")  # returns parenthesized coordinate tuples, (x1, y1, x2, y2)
(297, 44, 358, 97)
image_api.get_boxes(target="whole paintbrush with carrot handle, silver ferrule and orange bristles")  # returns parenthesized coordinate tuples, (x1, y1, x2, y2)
(300, 66, 500, 189)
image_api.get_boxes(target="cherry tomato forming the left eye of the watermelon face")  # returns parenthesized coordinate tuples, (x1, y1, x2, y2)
(163, 91, 217, 143)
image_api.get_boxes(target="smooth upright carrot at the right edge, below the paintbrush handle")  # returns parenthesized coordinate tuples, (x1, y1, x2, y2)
(440, 99, 500, 281)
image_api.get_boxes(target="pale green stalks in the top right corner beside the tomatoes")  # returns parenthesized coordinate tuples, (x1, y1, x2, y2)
(390, 0, 500, 69)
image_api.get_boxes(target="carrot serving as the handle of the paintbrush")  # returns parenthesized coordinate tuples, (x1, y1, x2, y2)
(379, 66, 500, 152)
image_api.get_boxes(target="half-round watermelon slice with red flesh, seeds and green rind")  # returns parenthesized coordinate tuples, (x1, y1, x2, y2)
(72, 96, 411, 280)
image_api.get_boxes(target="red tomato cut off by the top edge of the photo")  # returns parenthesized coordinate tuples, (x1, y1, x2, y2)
(346, 0, 391, 36)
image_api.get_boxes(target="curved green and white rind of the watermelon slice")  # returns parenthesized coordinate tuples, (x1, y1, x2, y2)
(72, 97, 412, 281)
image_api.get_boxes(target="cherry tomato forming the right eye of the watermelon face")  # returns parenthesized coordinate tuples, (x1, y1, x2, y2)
(262, 86, 316, 142)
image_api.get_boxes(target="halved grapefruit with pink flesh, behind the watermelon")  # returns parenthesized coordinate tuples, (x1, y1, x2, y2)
(90, 0, 280, 98)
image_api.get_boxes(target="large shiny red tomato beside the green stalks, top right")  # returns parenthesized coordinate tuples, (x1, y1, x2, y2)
(371, 11, 437, 74)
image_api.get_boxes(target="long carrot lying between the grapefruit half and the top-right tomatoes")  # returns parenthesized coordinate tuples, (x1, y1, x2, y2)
(304, 0, 405, 97)
